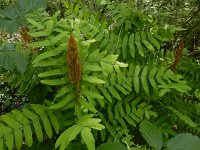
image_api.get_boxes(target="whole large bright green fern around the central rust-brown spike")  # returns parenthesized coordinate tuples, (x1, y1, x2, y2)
(1, 0, 196, 150)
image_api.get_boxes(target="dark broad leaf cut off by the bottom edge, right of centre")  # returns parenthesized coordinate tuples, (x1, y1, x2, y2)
(97, 142, 128, 150)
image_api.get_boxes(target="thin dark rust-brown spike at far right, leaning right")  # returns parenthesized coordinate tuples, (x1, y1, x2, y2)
(171, 40, 184, 72)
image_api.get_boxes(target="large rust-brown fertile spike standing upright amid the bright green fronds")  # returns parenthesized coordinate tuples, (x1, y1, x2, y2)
(66, 35, 81, 97)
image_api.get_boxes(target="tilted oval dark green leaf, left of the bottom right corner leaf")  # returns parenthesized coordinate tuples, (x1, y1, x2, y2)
(139, 120, 163, 150)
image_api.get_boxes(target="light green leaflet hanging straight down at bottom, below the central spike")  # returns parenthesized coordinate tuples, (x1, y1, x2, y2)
(81, 127, 95, 150)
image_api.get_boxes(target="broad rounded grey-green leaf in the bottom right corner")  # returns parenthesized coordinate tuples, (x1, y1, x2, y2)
(167, 133, 200, 150)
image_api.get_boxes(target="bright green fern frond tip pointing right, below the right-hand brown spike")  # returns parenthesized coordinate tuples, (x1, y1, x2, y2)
(128, 64, 190, 96)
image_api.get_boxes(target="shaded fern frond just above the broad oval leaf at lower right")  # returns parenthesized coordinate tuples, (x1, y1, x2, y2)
(101, 95, 157, 139)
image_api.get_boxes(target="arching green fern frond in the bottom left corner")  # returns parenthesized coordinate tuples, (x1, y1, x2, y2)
(0, 104, 59, 150)
